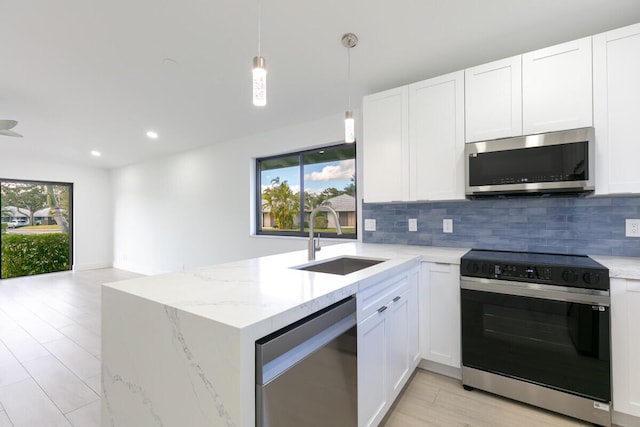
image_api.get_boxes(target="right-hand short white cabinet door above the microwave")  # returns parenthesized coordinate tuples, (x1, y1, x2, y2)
(522, 37, 593, 135)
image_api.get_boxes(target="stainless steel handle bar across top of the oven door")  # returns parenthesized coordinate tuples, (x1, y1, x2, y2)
(460, 276, 611, 307)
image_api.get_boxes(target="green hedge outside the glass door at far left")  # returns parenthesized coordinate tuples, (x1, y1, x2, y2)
(0, 233, 69, 279)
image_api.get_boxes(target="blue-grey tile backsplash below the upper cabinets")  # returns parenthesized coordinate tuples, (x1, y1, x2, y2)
(362, 196, 640, 257)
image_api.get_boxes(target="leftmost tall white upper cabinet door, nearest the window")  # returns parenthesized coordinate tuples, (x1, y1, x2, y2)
(362, 86, 409, 202)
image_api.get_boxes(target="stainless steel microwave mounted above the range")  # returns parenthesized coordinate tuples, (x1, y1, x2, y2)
(465, 127, 595, 197)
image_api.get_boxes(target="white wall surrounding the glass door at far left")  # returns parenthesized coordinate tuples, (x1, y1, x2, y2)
(0, 156, 113, 270)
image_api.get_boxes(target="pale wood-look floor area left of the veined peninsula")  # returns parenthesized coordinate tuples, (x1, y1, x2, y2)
(0, 269, 138, 427)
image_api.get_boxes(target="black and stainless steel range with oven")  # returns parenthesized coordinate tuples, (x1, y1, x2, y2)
(460, 250, 611, 426)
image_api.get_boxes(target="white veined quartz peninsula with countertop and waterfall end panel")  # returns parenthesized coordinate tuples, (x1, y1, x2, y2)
(102, 243, 465, 427)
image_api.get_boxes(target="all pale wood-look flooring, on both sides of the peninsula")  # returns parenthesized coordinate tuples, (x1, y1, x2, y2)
(0, 269, 608, 427)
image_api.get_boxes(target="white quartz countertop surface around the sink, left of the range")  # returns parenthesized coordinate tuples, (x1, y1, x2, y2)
(105, 242, 466, 332)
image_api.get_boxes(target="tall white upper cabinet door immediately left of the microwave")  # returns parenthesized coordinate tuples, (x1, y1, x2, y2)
(409, 71, 464, 200)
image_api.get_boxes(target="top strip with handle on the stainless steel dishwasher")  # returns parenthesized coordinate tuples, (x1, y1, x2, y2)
(256, 297, 356, 385)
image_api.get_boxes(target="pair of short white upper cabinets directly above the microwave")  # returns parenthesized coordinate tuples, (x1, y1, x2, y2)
(465, 37, 593, 142)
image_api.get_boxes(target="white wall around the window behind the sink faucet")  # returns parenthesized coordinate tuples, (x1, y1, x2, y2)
(112, 114, 362, 274)
